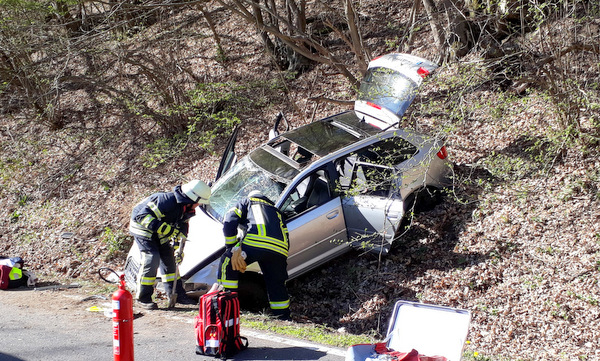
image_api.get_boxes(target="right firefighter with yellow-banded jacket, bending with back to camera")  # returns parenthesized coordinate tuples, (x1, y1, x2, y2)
(218, 191, 290, 320)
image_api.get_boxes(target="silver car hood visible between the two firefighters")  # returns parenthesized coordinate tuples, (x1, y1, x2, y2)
(179, 210, 225, 285)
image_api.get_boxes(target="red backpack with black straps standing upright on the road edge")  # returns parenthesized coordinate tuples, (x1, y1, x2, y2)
(194, 291, 248, 359)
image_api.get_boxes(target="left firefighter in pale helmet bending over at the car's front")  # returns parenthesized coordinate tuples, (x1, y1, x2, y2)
(129, 180, 211, 309)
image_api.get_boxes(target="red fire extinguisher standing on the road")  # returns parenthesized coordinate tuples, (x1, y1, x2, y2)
(100, 270, 133, 361)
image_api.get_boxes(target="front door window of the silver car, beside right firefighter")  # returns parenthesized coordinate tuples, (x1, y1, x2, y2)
(281, 170, 332, 218)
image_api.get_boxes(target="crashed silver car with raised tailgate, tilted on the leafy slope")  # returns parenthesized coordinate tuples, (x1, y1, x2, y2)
(126, 54, 449, 289)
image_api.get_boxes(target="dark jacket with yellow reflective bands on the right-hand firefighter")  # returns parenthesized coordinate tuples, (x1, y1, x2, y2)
(223, 197, 289, 257)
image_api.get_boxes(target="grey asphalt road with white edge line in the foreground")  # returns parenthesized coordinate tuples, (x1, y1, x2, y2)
(0, 290, 345, 361)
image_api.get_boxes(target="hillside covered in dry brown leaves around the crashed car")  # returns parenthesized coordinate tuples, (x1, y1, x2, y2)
(0, 1, 600, 360)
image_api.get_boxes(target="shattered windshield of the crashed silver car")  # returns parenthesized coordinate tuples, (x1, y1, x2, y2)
(206, 157, 285, 221)
